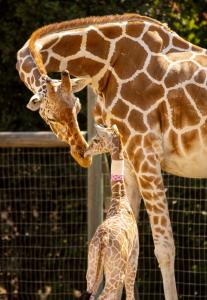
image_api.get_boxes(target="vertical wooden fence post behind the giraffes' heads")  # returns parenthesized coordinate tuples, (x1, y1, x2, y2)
(87, 87, 103, 241)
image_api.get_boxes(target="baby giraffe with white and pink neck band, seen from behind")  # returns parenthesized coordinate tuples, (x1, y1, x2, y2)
(84, 126, 139, 300)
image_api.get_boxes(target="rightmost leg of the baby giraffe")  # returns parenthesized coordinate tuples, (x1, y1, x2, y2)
(125, 238, 139, 300)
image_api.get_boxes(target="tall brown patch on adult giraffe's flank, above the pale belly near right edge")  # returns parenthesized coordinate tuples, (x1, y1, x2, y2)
(168, 88, 200, 128)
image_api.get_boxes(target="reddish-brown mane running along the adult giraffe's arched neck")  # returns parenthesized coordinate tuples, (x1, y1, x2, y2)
(29, 13, 170, 74)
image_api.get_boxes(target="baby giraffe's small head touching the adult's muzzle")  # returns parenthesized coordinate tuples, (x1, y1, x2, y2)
(84, 125, 122, 159)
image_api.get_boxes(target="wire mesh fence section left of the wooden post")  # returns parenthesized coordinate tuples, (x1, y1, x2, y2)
(0, 148, 87, 300)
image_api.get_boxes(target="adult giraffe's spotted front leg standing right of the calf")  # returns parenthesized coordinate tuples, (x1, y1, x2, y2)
(129, 148, 177, 300)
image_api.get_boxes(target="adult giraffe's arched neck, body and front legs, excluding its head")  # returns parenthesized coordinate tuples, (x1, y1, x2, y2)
(17, 14, 207, 300)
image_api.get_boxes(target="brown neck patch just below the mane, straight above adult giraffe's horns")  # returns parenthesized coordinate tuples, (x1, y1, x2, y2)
(53, 35, 82, 57)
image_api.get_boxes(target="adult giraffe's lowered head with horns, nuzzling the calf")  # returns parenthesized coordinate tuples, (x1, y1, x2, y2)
(39, 71, 91, 167)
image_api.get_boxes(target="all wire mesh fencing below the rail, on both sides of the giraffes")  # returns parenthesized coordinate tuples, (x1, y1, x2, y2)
(0, 141, 207, 300)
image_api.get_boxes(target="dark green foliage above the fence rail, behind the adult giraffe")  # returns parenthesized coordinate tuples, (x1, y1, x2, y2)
(0, 0, 207, 131)
